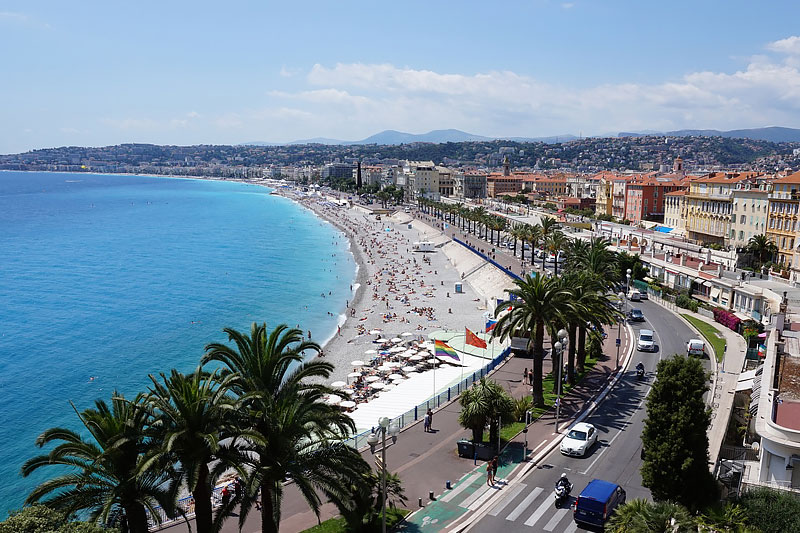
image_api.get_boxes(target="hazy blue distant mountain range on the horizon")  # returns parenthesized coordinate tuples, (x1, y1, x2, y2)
(242, 126, 800, 146)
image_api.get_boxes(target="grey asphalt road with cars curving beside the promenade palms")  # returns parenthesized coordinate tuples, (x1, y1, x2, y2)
(470, 301, 708, 533)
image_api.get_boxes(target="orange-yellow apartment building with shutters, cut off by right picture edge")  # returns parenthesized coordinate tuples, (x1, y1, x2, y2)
(767, 172, 800, 269)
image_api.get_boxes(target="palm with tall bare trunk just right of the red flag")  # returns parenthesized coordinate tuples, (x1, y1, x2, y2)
(492, 274, 572, 407)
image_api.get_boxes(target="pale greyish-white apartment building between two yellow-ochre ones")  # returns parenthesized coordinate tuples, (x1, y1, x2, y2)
(728, 179, 769, 248)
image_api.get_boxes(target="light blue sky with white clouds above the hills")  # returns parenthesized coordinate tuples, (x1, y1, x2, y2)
(0, 0, 800, 154)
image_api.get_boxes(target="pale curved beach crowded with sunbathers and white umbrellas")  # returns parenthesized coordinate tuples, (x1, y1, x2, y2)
(279, 188, 512, 430)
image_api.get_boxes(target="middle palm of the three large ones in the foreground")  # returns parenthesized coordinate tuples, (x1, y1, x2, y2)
(147, 369, 243, 533)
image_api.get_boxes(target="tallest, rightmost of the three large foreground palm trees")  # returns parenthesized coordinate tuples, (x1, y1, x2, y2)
(201, 323, 369, 532)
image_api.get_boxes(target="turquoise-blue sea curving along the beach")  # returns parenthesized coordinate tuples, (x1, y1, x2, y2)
(0, 172, 355, 520)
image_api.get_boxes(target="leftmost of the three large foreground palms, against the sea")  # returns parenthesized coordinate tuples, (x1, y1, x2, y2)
(22, 391, 177, 533)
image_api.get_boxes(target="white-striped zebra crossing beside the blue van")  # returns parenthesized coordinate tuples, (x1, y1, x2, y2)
(443, 476, 578, 533)
